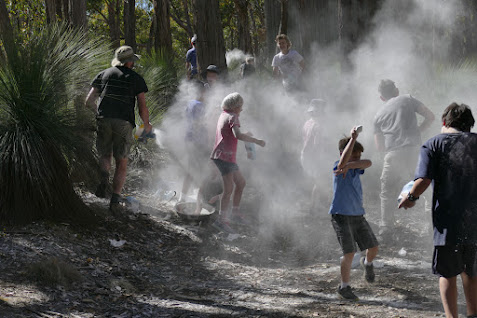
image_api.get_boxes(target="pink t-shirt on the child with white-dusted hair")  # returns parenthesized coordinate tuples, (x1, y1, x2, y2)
(210, 110, 240, 163)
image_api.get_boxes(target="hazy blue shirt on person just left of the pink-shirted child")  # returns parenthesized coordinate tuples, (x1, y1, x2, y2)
(185, 100, 208, 147)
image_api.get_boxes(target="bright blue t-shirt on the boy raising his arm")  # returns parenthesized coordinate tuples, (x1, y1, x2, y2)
(329, 161, 365, 215)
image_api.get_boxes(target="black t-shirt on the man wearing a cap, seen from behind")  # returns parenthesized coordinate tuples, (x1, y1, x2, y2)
(91, 66, 148, 126)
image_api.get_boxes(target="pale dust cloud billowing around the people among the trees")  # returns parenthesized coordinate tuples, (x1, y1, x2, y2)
(153, 0, 477, 260)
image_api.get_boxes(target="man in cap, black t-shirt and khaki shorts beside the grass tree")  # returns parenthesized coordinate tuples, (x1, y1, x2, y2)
(86, 46, 152, 212)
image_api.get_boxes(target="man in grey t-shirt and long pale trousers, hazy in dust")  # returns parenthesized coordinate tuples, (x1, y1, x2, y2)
(374, 79, 434, 239)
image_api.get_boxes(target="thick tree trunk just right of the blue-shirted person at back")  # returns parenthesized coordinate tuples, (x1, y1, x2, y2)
(192, 0, 227, 77)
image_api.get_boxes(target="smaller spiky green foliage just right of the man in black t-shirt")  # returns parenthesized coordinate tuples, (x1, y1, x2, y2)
(136, 51, 177, 124)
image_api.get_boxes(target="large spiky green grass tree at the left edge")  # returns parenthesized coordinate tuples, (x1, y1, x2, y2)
(0, 25, 108, 223)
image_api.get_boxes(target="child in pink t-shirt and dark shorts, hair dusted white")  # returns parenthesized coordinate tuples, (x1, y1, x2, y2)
(211, 93, 265, 233)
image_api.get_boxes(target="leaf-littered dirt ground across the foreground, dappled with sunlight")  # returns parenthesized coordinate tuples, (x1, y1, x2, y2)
(0, 185, 456, 317)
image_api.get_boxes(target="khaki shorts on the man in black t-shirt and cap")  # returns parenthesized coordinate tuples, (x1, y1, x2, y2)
(96, 118, 133, 159)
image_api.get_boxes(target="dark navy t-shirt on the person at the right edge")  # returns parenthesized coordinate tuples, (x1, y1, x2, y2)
(415, 132, 477, 246)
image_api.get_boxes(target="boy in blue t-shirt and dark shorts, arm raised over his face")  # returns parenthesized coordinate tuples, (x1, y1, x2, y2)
(329, 127, 378, 300)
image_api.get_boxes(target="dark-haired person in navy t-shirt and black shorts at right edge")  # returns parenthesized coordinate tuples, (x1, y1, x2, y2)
(399, 103, 477, 317)
